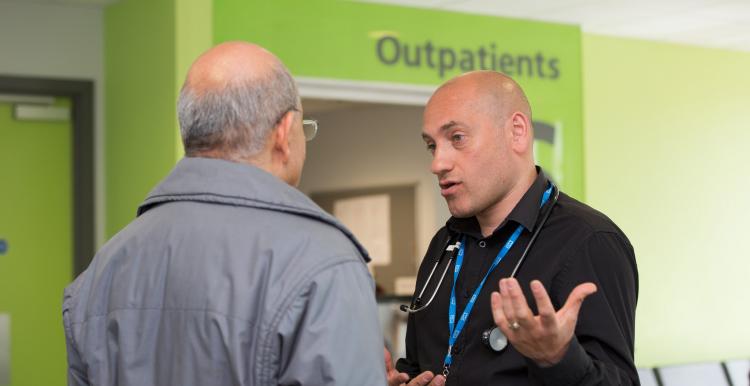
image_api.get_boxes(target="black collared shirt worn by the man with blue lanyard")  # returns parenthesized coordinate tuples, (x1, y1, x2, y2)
(396, 169, 639, 386)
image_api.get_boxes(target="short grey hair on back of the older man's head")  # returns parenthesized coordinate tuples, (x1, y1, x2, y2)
(177, 63, 300, 160)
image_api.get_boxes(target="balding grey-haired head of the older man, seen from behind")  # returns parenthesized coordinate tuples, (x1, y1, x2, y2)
(178, 42, 300, 160)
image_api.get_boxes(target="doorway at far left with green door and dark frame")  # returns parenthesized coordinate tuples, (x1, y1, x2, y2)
(0, 76, 95, 386)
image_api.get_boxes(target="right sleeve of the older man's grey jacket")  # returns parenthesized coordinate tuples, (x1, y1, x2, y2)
(278, 261, 386, 385)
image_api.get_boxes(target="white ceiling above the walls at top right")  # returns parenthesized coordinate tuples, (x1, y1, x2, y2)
(360, 0, 750, 51)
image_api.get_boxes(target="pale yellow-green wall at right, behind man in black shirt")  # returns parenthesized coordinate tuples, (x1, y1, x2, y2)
(583, 35, 750, 365)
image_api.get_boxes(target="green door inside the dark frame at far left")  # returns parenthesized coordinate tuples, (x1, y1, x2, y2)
(0, 99, 73, 386)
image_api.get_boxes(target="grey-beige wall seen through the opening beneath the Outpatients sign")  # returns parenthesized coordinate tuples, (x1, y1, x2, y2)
(300, 102, 450, 262)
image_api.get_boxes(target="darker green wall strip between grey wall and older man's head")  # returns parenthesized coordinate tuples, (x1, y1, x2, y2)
(104, 0, 177, 237)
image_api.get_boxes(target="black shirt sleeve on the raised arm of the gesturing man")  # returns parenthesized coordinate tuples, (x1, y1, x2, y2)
(527, 232, 639, 386)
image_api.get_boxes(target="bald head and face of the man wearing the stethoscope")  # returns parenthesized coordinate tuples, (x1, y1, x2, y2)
(422, 71, 536, 226)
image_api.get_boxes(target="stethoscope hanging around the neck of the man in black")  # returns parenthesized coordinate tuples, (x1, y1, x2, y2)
(399, 184, 560, 352)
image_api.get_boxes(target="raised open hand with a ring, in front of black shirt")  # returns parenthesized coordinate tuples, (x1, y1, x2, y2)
(492, 278, 596, 366)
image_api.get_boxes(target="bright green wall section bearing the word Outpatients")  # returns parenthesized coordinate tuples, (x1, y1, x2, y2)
(213, 0, 583, 198)
